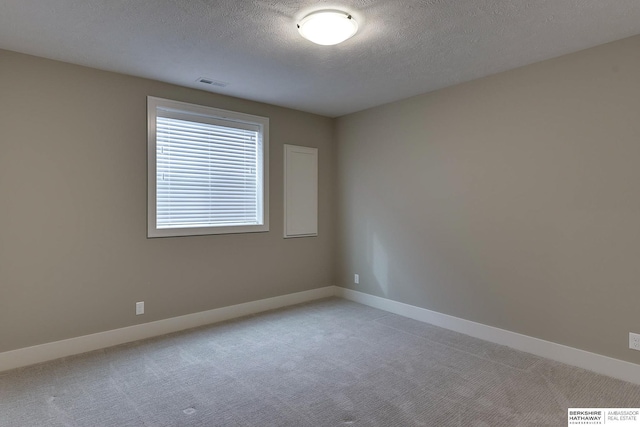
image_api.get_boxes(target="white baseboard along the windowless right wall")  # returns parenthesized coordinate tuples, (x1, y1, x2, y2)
(335, 287, 640, 384)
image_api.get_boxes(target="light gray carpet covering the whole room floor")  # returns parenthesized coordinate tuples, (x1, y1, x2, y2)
(0, 298, 640, 427)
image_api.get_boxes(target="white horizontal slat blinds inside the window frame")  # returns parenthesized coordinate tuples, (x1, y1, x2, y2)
(147, 97, 265, 235)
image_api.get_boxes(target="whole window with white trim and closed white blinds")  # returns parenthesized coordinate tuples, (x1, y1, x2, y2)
(147, 97, 269, 237)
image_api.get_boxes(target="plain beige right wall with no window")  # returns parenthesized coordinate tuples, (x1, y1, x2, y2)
(336, 37, 640, 363)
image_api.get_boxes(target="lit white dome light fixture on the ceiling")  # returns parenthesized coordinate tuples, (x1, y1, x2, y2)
(298, 10, 358, 46)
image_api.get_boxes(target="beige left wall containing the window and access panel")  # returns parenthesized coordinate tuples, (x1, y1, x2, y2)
(0, 51, 334, 352)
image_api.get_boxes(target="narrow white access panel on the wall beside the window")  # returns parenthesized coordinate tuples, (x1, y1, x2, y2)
(284, 144, 318, 238)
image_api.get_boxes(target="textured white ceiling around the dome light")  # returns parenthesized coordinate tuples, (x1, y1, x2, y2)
(0, 0, 640, 117)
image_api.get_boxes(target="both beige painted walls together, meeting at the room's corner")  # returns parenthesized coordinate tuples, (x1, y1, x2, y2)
(0, 37, 640, 363)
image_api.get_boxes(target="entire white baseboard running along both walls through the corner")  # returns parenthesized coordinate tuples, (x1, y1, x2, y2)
(6, 286, 640, 384)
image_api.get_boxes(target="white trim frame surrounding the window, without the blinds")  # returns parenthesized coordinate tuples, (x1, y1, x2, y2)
(147, 96, 269, 238)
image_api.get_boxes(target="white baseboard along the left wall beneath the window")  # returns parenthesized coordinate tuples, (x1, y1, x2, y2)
(0, 286, 336, 372)
